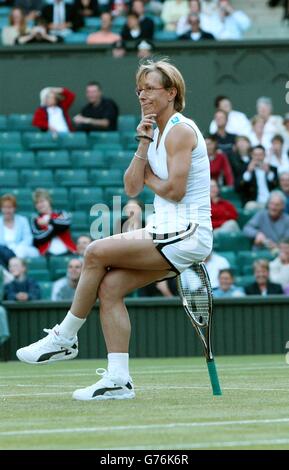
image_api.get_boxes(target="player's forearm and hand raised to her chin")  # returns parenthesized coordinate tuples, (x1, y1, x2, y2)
(124, 114, 155, 197)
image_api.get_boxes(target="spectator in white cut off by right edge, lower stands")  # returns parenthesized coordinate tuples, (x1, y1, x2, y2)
(269, 238, 289, 292)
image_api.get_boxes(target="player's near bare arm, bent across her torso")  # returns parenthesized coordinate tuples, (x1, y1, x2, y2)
(145, 124, 197, 202)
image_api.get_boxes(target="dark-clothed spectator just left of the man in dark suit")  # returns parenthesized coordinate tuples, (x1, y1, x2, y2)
(229, 135, 251, 185)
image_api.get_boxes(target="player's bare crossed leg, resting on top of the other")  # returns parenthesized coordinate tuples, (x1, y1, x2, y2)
(70, 230, 169, 319)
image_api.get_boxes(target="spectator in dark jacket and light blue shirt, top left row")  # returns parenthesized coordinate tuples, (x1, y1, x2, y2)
(41, 0, 84, 37)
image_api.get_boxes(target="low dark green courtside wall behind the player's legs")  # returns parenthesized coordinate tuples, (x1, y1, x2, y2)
(0, 296, 289, 359)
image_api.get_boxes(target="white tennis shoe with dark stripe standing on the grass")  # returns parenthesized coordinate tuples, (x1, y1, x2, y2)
(72, 369, 135, 400)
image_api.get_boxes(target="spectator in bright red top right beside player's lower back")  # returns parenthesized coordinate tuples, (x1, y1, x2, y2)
(211, 180, 238, 230)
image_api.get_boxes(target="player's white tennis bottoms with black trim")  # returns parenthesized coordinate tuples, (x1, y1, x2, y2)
(147, 223, 213, 277)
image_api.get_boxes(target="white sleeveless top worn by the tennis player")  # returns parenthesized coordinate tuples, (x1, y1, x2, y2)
(147, 113, 212, 233)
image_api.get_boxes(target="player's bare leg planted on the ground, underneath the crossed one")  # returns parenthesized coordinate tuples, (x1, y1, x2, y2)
(99, 269, 168, 353)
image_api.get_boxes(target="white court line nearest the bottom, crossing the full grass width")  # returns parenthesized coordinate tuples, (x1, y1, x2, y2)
(0, 418, 289, 436)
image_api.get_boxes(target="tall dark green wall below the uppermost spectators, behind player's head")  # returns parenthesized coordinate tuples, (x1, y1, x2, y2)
(0, 41, 289, 131)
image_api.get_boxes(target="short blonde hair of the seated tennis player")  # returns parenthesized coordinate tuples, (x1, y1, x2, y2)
(136, 59, 186, 112)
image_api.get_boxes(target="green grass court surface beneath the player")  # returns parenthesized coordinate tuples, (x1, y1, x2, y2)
(0, 356, 289, 450)
